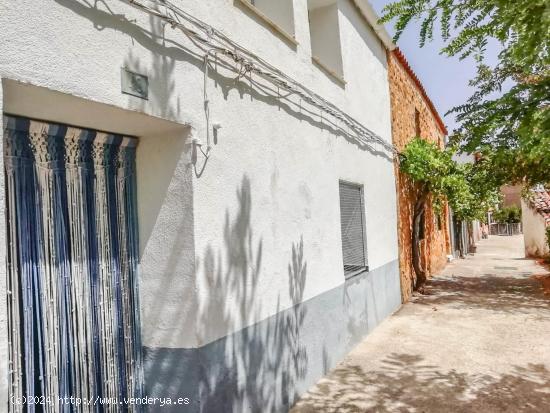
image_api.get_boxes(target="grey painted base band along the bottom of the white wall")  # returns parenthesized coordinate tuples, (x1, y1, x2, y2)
(144, 260, 401, 413)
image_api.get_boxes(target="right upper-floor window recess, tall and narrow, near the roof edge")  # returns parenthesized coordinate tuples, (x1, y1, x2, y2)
(307, 0, 344, 82)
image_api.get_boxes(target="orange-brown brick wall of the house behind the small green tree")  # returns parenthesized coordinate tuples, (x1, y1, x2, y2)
(388, 50, 450, 302)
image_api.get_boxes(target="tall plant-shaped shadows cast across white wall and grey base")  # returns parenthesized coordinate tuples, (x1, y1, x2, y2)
(197, 176, 308, 412)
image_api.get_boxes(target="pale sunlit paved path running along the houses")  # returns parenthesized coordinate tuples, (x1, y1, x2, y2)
(292, 236, 550, 413)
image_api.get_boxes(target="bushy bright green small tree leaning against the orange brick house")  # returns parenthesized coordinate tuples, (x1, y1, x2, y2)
(400, 137, 499, 220)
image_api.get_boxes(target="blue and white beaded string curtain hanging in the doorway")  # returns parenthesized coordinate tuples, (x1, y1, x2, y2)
(4, 116, 142, 412)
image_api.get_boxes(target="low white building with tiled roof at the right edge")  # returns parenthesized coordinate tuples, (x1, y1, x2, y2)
(521, 187, 550, 257)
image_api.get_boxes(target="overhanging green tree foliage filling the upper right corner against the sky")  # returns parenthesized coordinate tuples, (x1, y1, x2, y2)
(381, 0, 550, 185)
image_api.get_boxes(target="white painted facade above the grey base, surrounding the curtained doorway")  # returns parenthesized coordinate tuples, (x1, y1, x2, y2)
(0, 0, 398, 405)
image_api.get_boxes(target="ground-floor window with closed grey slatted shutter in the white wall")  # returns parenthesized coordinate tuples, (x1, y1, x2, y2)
(340, 181, 367, 277)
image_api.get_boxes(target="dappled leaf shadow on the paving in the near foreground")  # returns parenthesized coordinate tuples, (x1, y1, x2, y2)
(292, 353, 550, 413)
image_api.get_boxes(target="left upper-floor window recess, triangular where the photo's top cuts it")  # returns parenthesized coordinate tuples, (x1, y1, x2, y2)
(240, 0, 296, 43)
